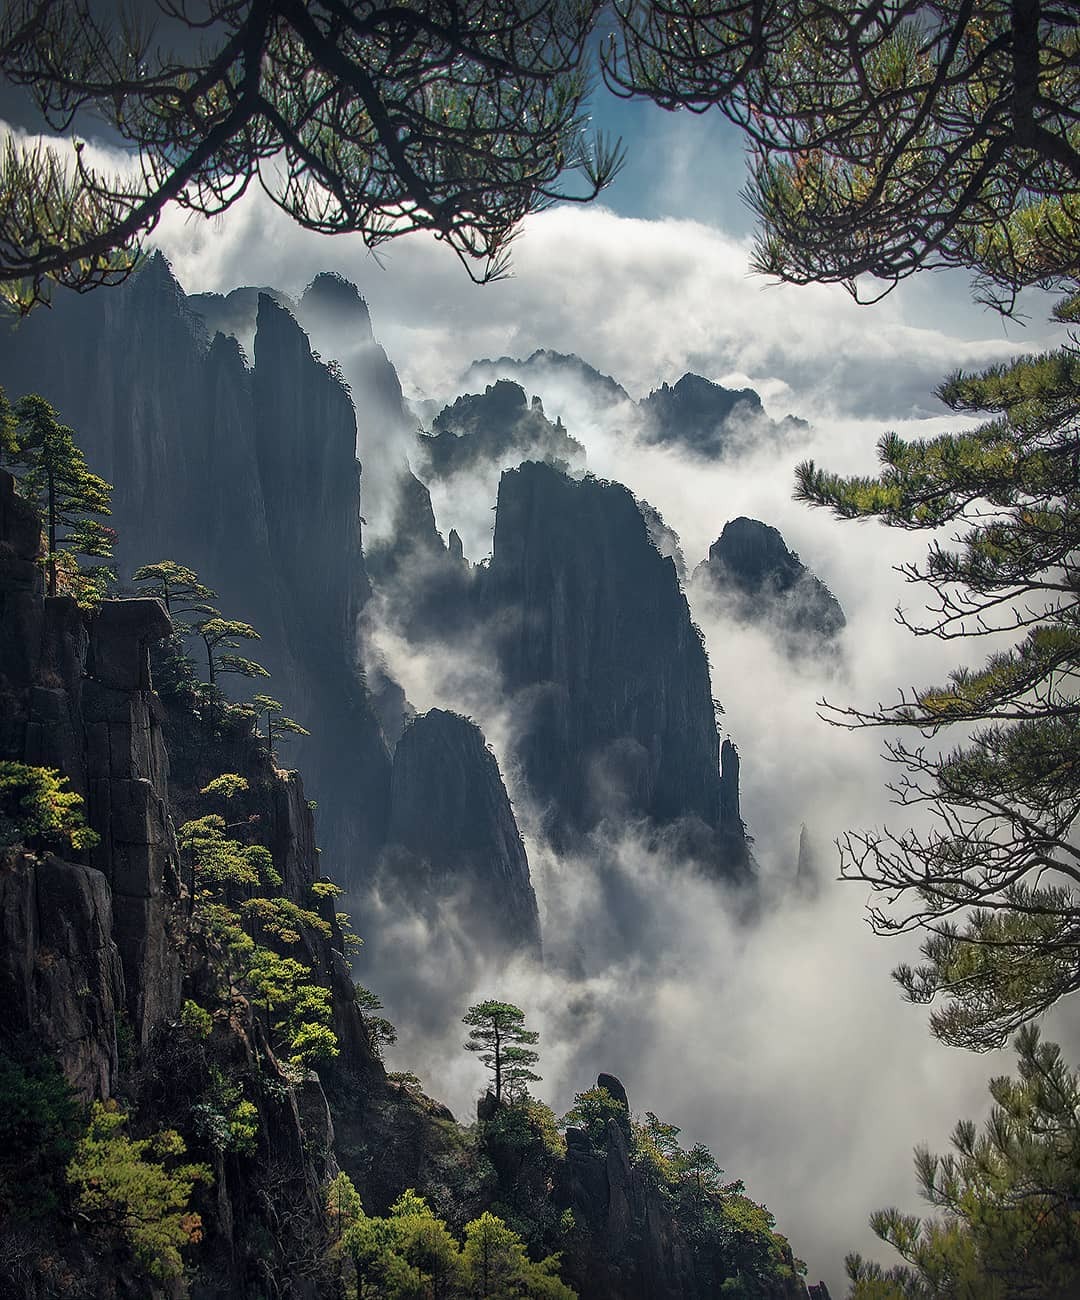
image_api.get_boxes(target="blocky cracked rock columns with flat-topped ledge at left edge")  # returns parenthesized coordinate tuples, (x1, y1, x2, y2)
(0, 471, 187, 1076)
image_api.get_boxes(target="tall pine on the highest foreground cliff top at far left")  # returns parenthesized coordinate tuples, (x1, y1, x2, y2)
(12, 394, 116, 603)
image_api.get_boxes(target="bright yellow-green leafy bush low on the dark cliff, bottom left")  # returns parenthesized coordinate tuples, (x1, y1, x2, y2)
(68, 1101, 211, 1281)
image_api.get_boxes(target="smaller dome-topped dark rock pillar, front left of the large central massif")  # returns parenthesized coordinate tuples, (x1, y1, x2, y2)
(381, 709, 541, 956)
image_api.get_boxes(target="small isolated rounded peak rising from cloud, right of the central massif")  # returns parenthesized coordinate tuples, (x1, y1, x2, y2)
(694, 517, 846, 651)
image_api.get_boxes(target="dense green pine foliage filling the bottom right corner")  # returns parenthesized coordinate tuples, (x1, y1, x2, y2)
(846, 1026, 1080, 1300)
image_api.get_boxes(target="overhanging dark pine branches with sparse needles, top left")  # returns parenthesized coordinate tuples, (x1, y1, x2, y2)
(0, 0, 617, 309)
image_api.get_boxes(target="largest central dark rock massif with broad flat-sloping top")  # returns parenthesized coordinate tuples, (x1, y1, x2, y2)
(483, 463, 742, 874)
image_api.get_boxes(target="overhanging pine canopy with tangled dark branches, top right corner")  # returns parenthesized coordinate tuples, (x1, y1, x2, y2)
(603, 0, 1080, 309)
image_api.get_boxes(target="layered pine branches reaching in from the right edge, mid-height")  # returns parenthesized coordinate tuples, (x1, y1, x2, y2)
(797, 347, 1080, 1049)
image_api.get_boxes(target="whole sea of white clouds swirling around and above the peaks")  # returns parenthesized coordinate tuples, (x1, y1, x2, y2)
(139, 180, 1070, 1294)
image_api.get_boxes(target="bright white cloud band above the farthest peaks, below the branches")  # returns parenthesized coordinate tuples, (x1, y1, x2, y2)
(148, 194, 1050, 419)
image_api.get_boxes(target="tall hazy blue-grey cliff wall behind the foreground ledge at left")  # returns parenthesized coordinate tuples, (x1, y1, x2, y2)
(0, 256, 390, 875)
